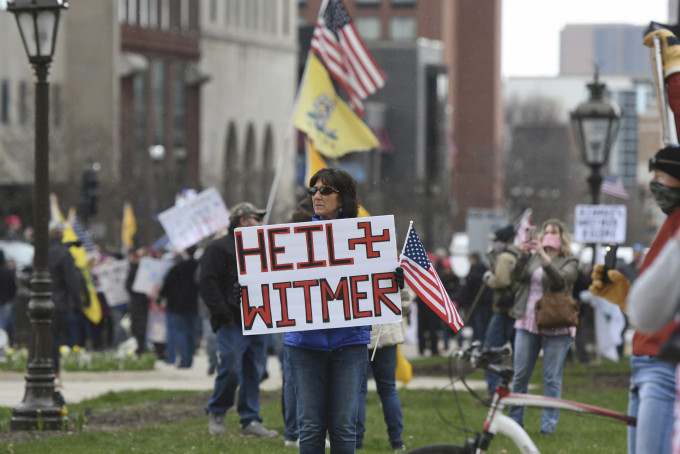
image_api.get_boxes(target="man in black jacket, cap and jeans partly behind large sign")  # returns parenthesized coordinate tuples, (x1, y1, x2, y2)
(199, 202, 278, 438)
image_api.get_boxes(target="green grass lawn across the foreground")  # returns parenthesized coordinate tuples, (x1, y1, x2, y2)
(0, 358, 629, 454)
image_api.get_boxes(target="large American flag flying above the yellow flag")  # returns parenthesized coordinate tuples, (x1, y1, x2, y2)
(311, 0, 385, 116)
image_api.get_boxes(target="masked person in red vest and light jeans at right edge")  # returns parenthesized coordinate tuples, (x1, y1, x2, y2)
(590, 146, 680, 454)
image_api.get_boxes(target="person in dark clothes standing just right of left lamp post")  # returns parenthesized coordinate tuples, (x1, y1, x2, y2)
(47, 221, 82, 388)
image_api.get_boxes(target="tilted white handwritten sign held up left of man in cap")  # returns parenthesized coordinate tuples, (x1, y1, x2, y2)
(158, 188, 229, 251)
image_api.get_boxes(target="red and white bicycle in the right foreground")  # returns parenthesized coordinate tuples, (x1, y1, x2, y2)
(409, 341, 637, 454)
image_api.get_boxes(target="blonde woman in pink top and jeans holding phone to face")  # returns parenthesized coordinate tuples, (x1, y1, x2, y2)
(509, 219, 578, 434)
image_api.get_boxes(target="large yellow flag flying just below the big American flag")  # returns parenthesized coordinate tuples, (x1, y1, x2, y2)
(293, 54, 378, 159)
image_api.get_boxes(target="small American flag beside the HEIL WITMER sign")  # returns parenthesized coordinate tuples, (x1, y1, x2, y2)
(399, 222, 463, 332)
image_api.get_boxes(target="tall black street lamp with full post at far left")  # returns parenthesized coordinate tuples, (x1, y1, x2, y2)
(7, 0, 68, 430)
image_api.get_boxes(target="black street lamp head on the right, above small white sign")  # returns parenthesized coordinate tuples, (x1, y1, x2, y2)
(571, 69, 621, 205)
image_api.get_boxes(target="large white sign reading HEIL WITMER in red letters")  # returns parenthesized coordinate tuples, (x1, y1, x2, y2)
(235, 216, 402, 334)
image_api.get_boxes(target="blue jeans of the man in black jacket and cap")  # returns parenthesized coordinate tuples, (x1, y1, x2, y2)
(205, 323, 265, 427)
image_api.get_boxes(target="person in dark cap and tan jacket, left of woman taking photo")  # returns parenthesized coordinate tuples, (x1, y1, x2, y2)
(484, 224, 521, 396)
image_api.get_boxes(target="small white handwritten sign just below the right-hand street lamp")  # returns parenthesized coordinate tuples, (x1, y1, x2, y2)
(574, 205, 627, 243)
